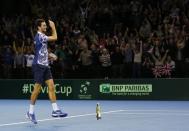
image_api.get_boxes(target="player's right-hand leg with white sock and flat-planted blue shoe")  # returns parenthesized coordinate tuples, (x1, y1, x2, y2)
(45, 68, 67, 117)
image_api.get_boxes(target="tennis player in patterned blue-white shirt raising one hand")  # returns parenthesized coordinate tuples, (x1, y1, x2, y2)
(27, 19, 68, 124)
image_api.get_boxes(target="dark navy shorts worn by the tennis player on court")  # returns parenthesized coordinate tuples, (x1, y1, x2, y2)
(32, 64, 52, 85)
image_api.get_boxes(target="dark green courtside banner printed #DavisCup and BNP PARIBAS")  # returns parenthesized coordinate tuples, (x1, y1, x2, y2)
(0, 79, 189, 100)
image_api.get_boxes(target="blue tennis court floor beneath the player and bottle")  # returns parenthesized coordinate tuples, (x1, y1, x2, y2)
(0, 100, 189, 131)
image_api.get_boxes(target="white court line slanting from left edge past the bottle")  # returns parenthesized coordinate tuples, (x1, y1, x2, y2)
(0, 110, 126, 127)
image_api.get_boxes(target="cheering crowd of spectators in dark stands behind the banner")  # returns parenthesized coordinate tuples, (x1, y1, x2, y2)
(0, 0, 189, 79)
